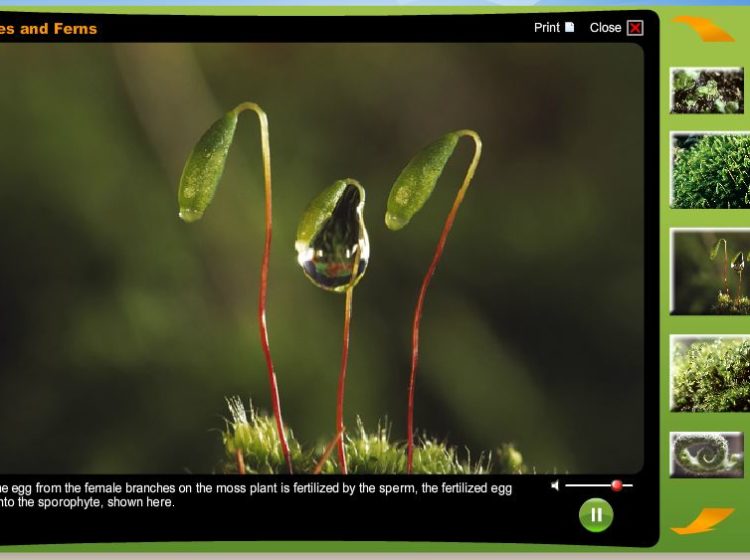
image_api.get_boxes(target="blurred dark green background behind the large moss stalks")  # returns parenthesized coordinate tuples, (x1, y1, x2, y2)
(0, 44, 644, 473)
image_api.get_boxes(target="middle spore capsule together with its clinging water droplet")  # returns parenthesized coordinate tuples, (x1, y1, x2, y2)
(295, 179, 370, 292)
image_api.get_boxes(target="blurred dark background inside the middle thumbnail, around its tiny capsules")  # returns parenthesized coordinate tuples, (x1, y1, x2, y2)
(672, 229, 750, 315)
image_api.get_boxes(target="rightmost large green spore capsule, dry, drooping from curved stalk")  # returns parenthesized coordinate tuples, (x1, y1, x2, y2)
(385, 131, 461, 230)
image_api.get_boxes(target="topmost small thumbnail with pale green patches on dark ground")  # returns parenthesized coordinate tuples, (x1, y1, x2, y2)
(671, 68, 745, 114)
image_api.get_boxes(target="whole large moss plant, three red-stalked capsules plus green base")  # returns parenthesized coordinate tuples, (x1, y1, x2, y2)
(178, 102, 506, 473)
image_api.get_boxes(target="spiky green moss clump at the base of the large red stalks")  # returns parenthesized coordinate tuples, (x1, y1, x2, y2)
(221, 397, 527, 474)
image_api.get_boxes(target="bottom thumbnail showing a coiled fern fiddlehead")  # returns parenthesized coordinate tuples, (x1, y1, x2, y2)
(670, 432, 745, 478)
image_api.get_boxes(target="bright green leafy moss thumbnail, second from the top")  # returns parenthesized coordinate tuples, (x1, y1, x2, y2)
(671, 132, 750, 209)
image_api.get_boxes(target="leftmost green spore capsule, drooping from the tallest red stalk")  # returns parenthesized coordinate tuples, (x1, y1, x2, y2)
(177, 110, 238, 222)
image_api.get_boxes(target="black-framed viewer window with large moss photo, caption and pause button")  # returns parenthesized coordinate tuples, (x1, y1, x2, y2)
(0, 12, 658, 545)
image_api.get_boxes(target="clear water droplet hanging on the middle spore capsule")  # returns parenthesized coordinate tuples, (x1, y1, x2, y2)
(296, 184, 370, 292)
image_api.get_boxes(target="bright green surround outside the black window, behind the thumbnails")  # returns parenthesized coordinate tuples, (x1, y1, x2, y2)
(0, 6, 750, 553)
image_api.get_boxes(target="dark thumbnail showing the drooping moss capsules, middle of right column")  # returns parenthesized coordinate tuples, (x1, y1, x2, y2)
(670, 228, 750, 315)
